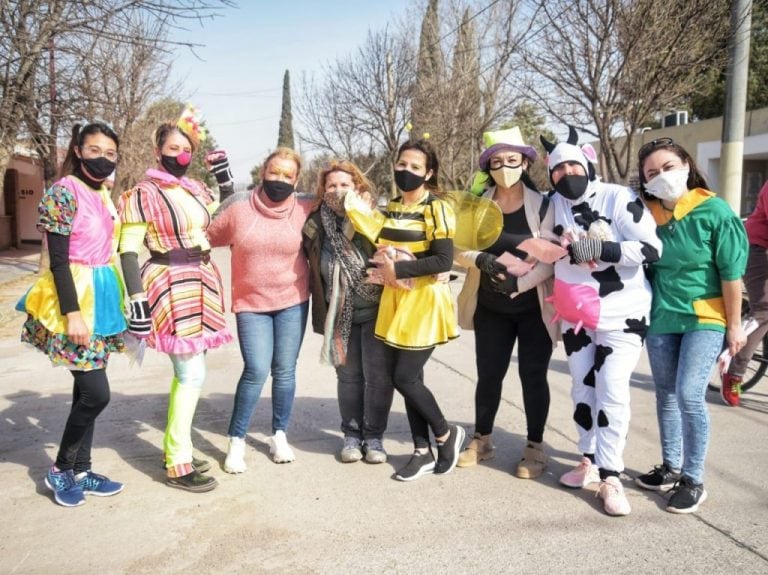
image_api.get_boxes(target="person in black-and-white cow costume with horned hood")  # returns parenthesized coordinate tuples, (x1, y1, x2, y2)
(541, 127, 661, 515)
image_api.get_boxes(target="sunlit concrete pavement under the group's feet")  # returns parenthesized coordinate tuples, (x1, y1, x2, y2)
(0, 252, 768, 574)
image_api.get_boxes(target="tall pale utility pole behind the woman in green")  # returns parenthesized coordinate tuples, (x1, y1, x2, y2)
(720, 0, 752, 215)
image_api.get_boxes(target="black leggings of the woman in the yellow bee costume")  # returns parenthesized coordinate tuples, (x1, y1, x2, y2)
(391, 347, 448, 449)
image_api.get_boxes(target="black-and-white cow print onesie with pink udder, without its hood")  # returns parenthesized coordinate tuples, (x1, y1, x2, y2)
(551, 179, 661, 472)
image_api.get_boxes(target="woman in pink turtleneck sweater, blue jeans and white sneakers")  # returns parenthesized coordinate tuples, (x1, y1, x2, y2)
(208, 148, 313, 473)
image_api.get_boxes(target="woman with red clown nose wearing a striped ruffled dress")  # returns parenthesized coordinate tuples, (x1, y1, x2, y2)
(119, 107, 232, 493)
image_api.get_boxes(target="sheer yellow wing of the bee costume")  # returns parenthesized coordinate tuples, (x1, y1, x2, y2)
(445, 190, 504, 250)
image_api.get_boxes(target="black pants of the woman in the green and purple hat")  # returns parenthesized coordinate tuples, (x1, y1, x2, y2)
(474, 304, 552, 442)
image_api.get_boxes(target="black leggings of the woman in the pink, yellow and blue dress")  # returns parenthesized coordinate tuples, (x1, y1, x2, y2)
(56, 369, 109, 473)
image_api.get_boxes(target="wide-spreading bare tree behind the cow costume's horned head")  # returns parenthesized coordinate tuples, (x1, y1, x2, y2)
(524, 0, 728, 182)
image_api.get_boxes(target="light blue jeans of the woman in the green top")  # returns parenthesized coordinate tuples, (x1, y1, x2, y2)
(646, 330, 723, 484)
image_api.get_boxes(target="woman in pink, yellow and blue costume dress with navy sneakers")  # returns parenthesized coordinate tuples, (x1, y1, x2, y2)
(16, 123, 126, 507)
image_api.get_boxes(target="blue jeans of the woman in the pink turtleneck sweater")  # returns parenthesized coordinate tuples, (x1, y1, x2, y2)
(229, 302, 309, 437)
